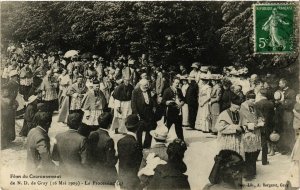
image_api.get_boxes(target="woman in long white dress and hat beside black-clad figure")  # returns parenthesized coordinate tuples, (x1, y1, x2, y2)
(195, 74, 212, 133)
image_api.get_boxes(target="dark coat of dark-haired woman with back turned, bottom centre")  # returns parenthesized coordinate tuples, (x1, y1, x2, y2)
(147, 163, 191, 190)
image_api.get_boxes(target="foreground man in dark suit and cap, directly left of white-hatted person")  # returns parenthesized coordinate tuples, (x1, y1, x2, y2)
(117, 114, 143, 190)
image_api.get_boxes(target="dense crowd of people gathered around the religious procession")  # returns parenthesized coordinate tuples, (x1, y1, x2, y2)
(1, 43, 300, 189)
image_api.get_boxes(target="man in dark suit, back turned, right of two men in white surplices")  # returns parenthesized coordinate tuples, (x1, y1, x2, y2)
(255, 88, 275, 165)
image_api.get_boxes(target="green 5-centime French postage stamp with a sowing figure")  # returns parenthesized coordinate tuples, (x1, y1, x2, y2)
(253, 4, 297, 54)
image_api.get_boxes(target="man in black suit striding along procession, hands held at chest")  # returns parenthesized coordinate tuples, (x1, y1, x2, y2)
(162, 78, 184, 140)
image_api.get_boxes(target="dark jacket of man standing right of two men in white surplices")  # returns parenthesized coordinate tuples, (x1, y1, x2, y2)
(255, 99, 274, 136)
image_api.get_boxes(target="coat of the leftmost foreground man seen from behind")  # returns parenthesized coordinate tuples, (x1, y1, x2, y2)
(27, 127, 54, 172)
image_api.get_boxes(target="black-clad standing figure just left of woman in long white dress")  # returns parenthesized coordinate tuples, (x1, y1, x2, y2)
(185, 76, 199, 129)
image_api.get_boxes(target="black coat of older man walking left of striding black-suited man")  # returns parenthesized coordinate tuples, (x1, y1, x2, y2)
(131, 88, 155, 122)
